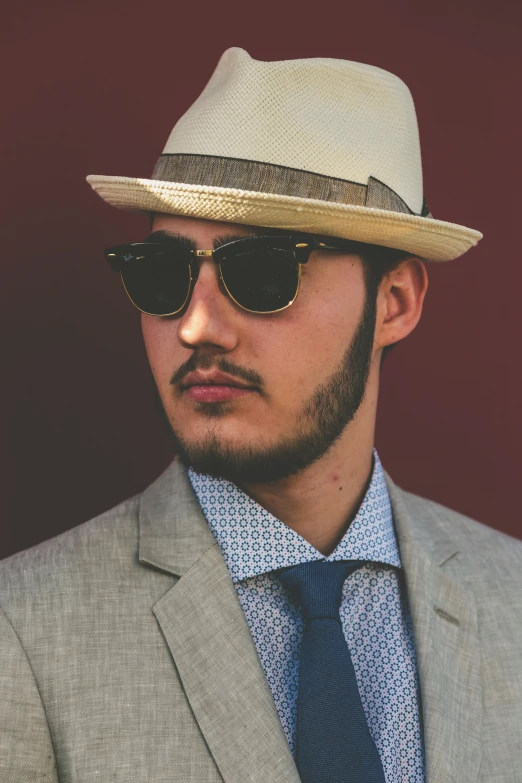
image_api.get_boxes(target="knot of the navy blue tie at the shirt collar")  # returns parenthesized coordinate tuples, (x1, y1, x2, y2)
(277, 560, 364, 621)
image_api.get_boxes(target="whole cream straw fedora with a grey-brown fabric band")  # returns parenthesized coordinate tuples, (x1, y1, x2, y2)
(87, 48, 482, 261)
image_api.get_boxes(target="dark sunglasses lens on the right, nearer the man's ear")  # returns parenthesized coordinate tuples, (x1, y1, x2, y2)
(221, 246, 299, 313)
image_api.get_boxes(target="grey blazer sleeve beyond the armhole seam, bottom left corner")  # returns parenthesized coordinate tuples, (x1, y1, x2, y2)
(0, 608, 59, 783)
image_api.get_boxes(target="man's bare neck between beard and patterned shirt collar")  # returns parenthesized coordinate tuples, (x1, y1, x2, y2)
(238, 427, 373, 555)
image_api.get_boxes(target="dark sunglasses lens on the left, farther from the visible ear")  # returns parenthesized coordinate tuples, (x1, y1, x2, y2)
(121, 245, 190, 315)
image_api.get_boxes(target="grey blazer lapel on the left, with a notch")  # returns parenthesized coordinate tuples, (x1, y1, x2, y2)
(139, 461, 299, 783)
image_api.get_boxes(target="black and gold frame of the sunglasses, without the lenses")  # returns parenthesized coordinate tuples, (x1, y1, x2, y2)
(104, 235, 360, 318)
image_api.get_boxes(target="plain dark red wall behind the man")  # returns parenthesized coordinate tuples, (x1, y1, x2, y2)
(0, 0, 522, 556)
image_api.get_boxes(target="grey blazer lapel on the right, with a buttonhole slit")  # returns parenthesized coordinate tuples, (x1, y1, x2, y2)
(387, 477, 482, 783)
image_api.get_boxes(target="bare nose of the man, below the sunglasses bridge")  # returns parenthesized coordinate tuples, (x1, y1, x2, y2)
(178, 258, 239, 351)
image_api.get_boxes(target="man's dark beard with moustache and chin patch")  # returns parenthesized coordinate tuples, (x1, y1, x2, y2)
(150, 292, 376, 485)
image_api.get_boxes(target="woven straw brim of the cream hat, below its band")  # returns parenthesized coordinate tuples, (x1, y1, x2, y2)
(87, 174, 482, 261)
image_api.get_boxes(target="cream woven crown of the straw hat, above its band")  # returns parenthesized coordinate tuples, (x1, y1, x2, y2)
(163, 47, 423, 214)
